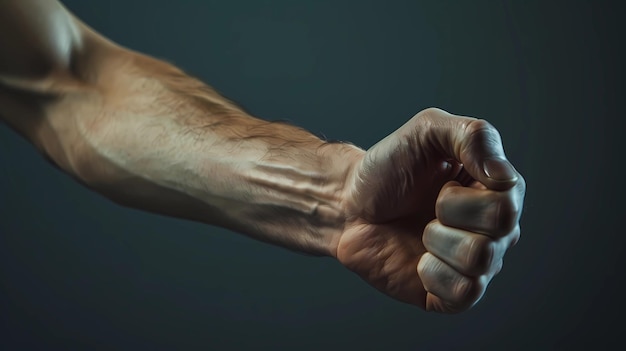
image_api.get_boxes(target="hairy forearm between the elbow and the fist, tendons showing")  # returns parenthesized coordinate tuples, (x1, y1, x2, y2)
(67, 52, 363, 255)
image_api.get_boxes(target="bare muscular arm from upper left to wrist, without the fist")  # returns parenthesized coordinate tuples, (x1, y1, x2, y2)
(0, 0, 363, 255)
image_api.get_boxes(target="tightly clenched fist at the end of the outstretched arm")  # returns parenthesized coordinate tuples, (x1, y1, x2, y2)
(337, 109, 526, 313)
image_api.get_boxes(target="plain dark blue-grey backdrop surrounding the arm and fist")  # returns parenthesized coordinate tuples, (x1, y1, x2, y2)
(0, 0, 625, 350)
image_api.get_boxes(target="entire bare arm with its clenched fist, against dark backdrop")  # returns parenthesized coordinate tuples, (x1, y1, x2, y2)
(0, 0, 525, 313)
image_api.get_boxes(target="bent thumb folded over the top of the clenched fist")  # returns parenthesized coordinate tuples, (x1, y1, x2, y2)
(416, 109, 519, 190)
